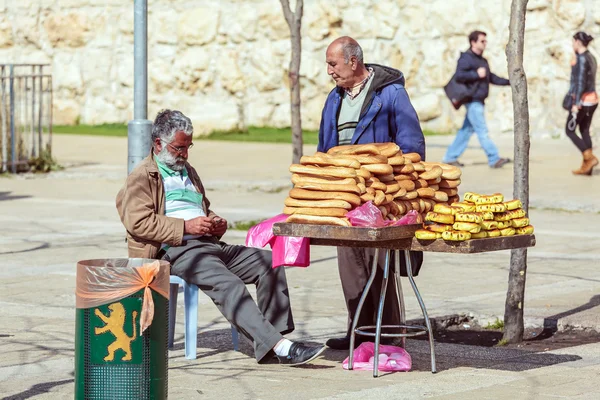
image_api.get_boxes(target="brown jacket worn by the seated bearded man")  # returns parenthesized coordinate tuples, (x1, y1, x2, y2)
(116, 153, 215, 258)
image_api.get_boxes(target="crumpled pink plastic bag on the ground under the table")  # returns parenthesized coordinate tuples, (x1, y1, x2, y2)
(342, 342, 412, 372)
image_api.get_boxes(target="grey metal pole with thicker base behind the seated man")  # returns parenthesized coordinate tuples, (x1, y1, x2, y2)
(127, 0, 152, 173)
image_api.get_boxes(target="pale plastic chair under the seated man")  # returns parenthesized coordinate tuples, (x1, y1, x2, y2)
(168, 275, 239, 360)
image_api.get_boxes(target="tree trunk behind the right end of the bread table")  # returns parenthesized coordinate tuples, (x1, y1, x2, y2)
(504, 0, 529, 343)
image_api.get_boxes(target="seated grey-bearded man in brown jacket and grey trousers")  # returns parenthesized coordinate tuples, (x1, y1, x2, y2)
(117, 110, 324, 365)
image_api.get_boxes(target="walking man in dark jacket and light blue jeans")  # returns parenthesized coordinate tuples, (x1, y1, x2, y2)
(443, 31, 510, 168)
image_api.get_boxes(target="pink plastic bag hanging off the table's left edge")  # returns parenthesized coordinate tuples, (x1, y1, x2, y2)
(246, 214, 310, 268)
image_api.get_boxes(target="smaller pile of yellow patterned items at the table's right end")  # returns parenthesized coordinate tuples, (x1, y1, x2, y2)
(415, 192, 534, 241)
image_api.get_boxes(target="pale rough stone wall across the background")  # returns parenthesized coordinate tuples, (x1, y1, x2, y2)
(0, 0, 600, 135)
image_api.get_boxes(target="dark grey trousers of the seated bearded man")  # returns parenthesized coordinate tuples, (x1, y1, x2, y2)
(163, 237, 294, 361)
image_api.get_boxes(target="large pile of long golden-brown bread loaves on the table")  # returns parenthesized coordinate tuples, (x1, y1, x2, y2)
(283, 142, 461, 226)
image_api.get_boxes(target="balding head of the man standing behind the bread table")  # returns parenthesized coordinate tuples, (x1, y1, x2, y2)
(325, 36, 369, 88)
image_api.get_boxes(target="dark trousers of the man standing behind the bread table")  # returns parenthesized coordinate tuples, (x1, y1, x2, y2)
(337, 247, 423, 336)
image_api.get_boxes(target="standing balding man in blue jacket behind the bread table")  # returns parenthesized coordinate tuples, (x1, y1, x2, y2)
(318, 36, 425, 350)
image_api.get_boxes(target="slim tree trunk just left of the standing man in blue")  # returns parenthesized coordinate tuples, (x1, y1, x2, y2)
(280, 0, 304, 164)
